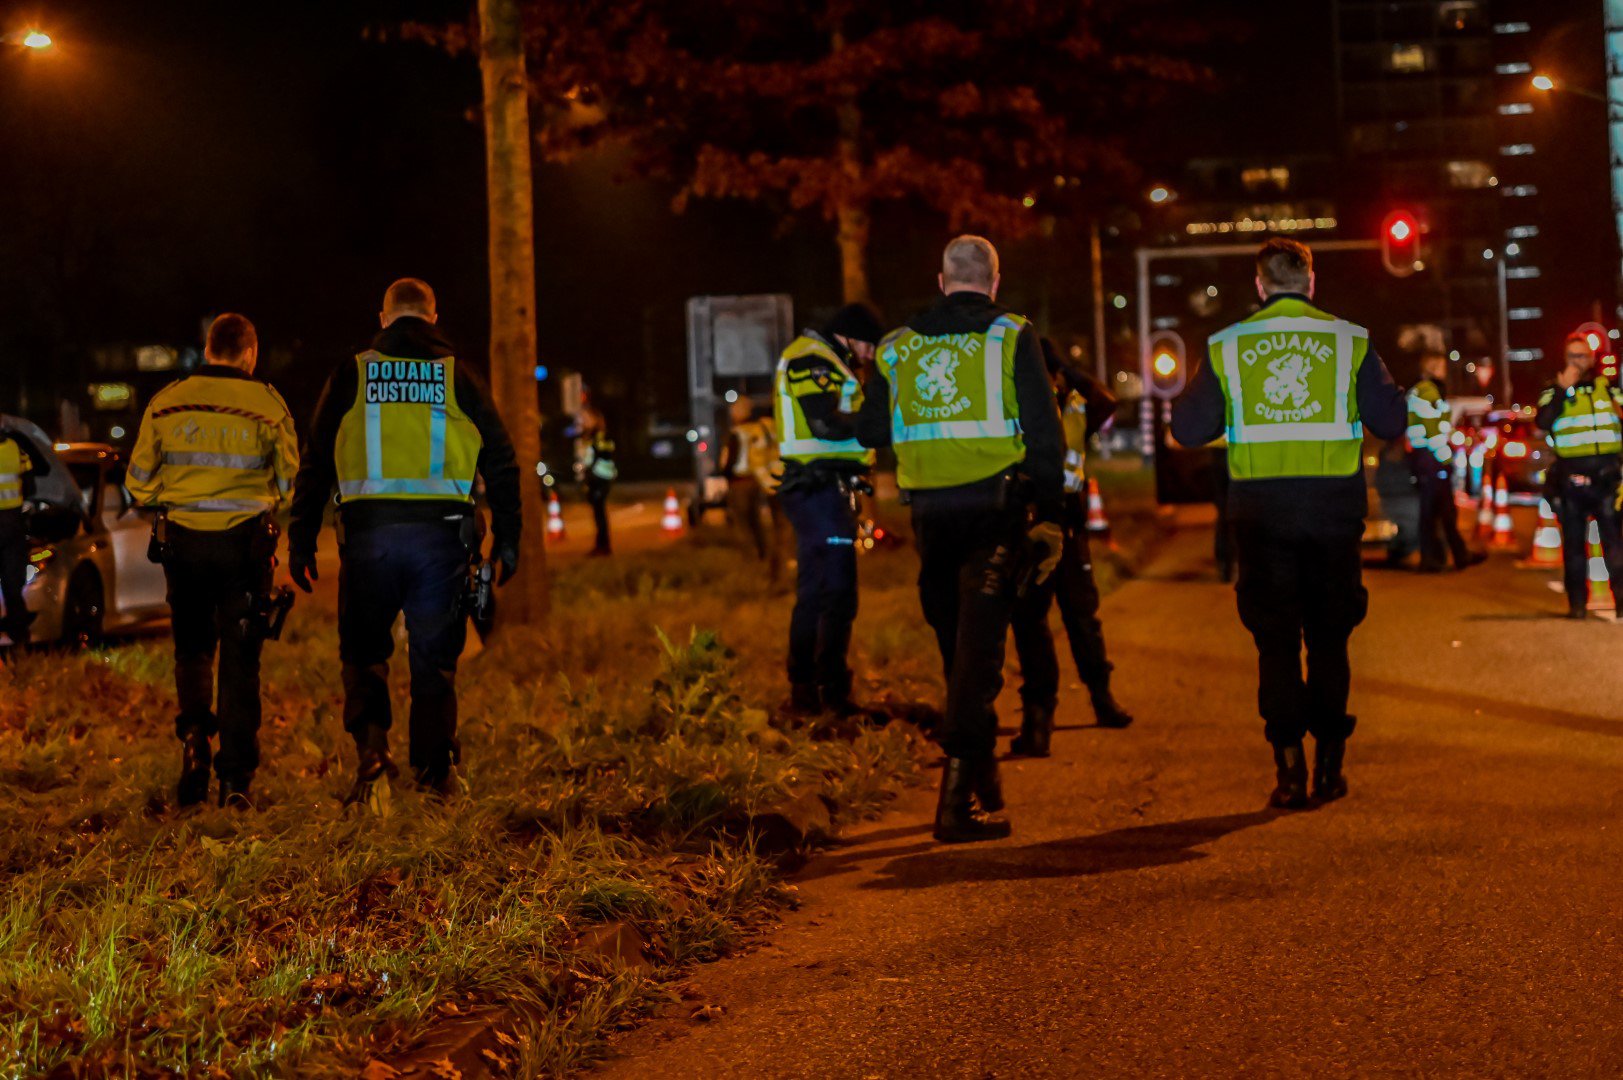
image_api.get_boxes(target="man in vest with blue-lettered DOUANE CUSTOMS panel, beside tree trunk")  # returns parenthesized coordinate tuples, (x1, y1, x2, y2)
(287, 278, 521, 801)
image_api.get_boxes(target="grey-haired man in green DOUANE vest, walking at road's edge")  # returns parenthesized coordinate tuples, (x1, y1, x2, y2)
(857, 235, 1065, 843)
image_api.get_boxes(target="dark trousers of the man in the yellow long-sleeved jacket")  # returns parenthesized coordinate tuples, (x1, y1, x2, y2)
(164, 520, 271, 783)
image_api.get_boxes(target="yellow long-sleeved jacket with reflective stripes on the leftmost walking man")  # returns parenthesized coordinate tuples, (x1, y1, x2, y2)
(127, 364, 299, 531)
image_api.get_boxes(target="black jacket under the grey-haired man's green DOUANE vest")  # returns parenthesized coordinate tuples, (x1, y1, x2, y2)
(857, 292, 1065, 521)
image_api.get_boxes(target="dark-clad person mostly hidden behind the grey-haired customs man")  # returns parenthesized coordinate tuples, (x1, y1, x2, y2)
(1010, 338, 1133, 757)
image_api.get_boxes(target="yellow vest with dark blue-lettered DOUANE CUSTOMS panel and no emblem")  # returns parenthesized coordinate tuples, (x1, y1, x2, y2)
(334, 351, 484, 500)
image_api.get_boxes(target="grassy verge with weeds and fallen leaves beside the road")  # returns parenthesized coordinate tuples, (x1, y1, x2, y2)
(0, 547, 933, 1077)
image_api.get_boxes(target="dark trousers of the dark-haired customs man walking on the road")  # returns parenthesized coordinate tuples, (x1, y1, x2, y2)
(1233, 518, 1370, 745)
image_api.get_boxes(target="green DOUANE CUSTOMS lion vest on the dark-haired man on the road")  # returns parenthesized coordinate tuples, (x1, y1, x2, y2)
(1209, 299, 1368, 479)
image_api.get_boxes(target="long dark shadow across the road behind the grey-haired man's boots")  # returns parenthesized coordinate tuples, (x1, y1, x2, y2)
(862, 810, 1281, 888)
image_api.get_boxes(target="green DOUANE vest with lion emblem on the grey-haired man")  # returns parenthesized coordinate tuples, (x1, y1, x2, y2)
(880, 315, 1026, 489)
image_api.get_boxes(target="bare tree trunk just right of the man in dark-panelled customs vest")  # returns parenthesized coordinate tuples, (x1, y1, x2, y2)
(479, 0, 549, 625)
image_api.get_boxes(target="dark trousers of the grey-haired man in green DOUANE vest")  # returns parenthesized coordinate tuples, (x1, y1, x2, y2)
(912, 500, 1024, 760)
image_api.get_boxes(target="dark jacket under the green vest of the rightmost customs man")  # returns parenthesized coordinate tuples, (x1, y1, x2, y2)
(1172, 292, 1409, 521)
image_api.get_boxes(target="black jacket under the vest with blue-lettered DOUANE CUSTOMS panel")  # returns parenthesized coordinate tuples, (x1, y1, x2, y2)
(287, 315, 523, 554)
